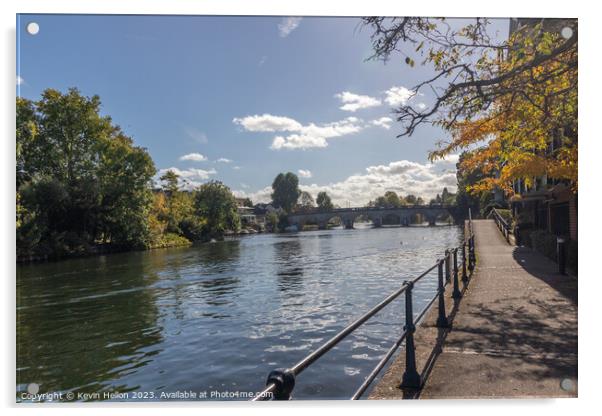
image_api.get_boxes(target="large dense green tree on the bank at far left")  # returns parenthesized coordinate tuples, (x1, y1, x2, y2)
(16, 88, 155, 257)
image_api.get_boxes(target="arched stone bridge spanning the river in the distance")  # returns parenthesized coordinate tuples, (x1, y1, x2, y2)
(288, 205, 458, 230)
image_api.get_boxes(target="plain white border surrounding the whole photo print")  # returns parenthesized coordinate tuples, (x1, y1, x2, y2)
(0, 0, 602, 416)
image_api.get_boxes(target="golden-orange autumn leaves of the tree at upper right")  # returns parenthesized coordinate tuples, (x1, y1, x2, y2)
(430, 27, 577, 194)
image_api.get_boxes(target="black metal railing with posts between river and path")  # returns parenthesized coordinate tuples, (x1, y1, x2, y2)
(252, 221, 476, 401)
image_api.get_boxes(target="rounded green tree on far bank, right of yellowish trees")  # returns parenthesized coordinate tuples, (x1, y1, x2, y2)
(194, 181, 240, 238)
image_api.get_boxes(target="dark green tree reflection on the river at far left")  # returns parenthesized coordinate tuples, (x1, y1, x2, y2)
(17, 250, 162, 393)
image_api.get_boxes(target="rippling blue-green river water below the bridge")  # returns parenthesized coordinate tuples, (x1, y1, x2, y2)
(17, 224, 462, 400)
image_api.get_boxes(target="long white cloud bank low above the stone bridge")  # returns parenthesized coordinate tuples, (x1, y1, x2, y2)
(235, 157, 456, 207)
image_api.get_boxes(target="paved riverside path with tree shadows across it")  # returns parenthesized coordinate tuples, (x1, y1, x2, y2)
(370, 220, 577, 399)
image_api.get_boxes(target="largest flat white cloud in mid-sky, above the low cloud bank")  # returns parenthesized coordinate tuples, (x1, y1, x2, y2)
(232, 114, 366, 150)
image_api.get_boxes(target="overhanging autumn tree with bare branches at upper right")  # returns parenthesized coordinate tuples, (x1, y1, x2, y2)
(364, 17, 578, 193)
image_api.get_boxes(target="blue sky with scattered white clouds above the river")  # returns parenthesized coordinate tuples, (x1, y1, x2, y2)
(17, 15, 508, 207)
